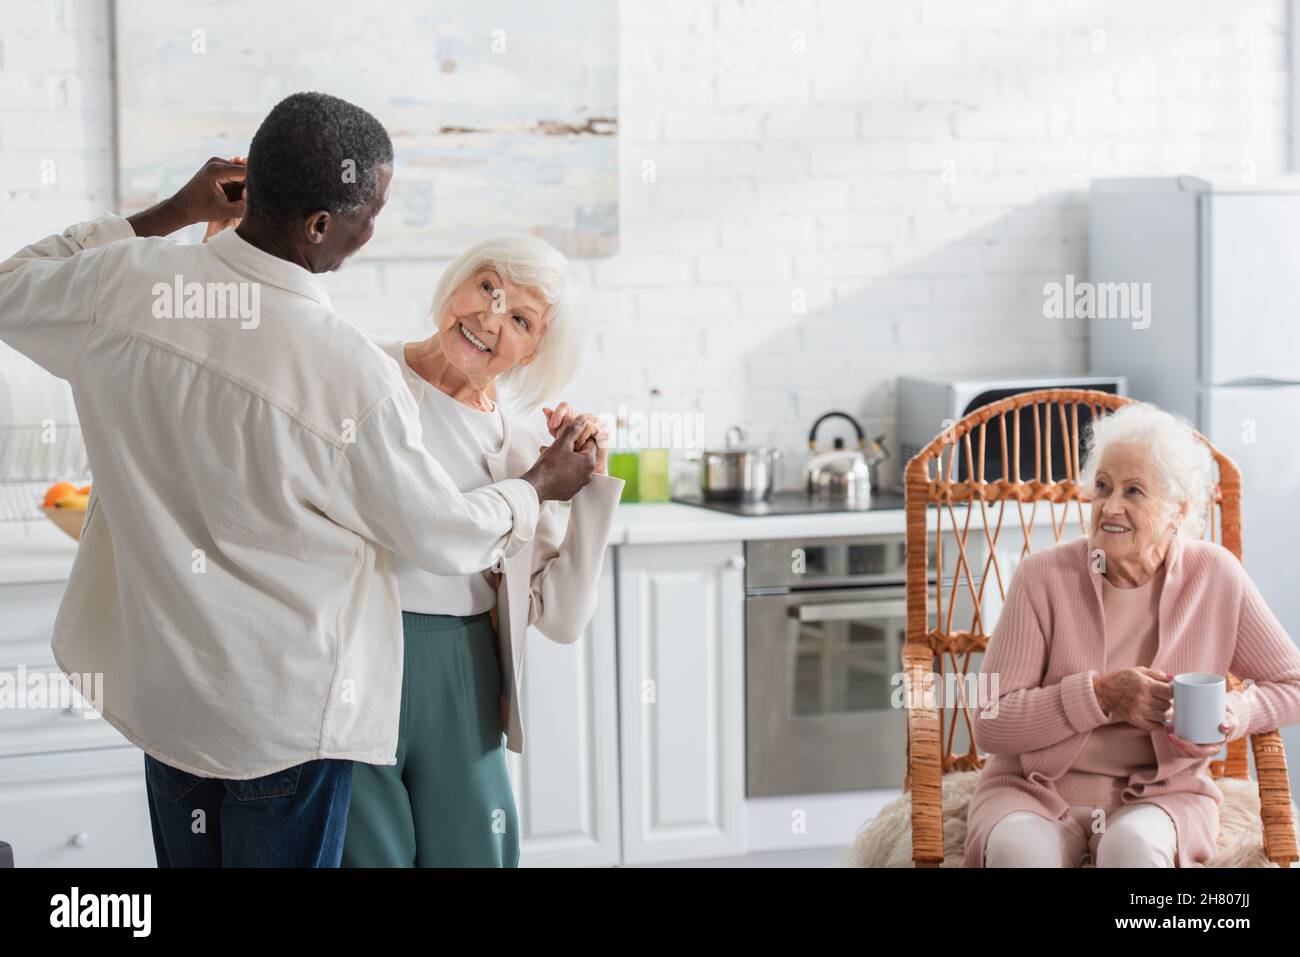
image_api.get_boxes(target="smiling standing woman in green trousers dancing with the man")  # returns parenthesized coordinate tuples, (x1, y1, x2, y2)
(342, 237, 623, 867)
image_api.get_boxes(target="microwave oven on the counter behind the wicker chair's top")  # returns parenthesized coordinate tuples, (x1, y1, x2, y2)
(898, 376, 1128, 482)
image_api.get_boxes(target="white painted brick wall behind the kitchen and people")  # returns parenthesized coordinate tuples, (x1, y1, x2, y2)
(0, 0, 1288, 485)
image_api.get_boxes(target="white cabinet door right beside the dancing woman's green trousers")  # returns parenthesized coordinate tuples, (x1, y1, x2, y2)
(507, 553, 619, 867)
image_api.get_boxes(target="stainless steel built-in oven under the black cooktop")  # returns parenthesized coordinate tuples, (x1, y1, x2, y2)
(745, 534, 907, 797)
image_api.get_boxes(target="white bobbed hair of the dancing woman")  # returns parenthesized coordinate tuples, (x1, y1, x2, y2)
(430, 234, 586, 412)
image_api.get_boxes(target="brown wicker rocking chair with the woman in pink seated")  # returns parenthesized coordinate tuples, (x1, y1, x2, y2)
(902, 389, 1297, 867)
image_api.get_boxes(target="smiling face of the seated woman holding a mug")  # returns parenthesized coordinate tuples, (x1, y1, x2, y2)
(1092, 442, 1186, 562)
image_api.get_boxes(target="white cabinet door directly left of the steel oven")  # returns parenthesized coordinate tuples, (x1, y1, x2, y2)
(618, 541, 745, 863)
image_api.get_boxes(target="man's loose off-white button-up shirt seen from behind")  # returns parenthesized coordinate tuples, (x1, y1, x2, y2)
(0, 215, 538, 778)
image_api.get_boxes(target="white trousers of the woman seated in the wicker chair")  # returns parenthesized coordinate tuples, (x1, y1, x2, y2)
(984, 804, 1178, 867)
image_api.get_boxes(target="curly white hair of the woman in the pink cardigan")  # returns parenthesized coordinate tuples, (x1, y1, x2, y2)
(1079, 402, 1218, 538)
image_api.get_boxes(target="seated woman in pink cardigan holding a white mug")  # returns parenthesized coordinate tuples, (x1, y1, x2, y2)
(963, 403, 1300, 867)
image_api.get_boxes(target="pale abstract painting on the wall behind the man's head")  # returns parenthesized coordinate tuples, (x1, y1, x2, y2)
(114, 0, 619, 259)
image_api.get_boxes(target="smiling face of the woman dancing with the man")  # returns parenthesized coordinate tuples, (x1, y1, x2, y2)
(438, 267, 549, 381)
